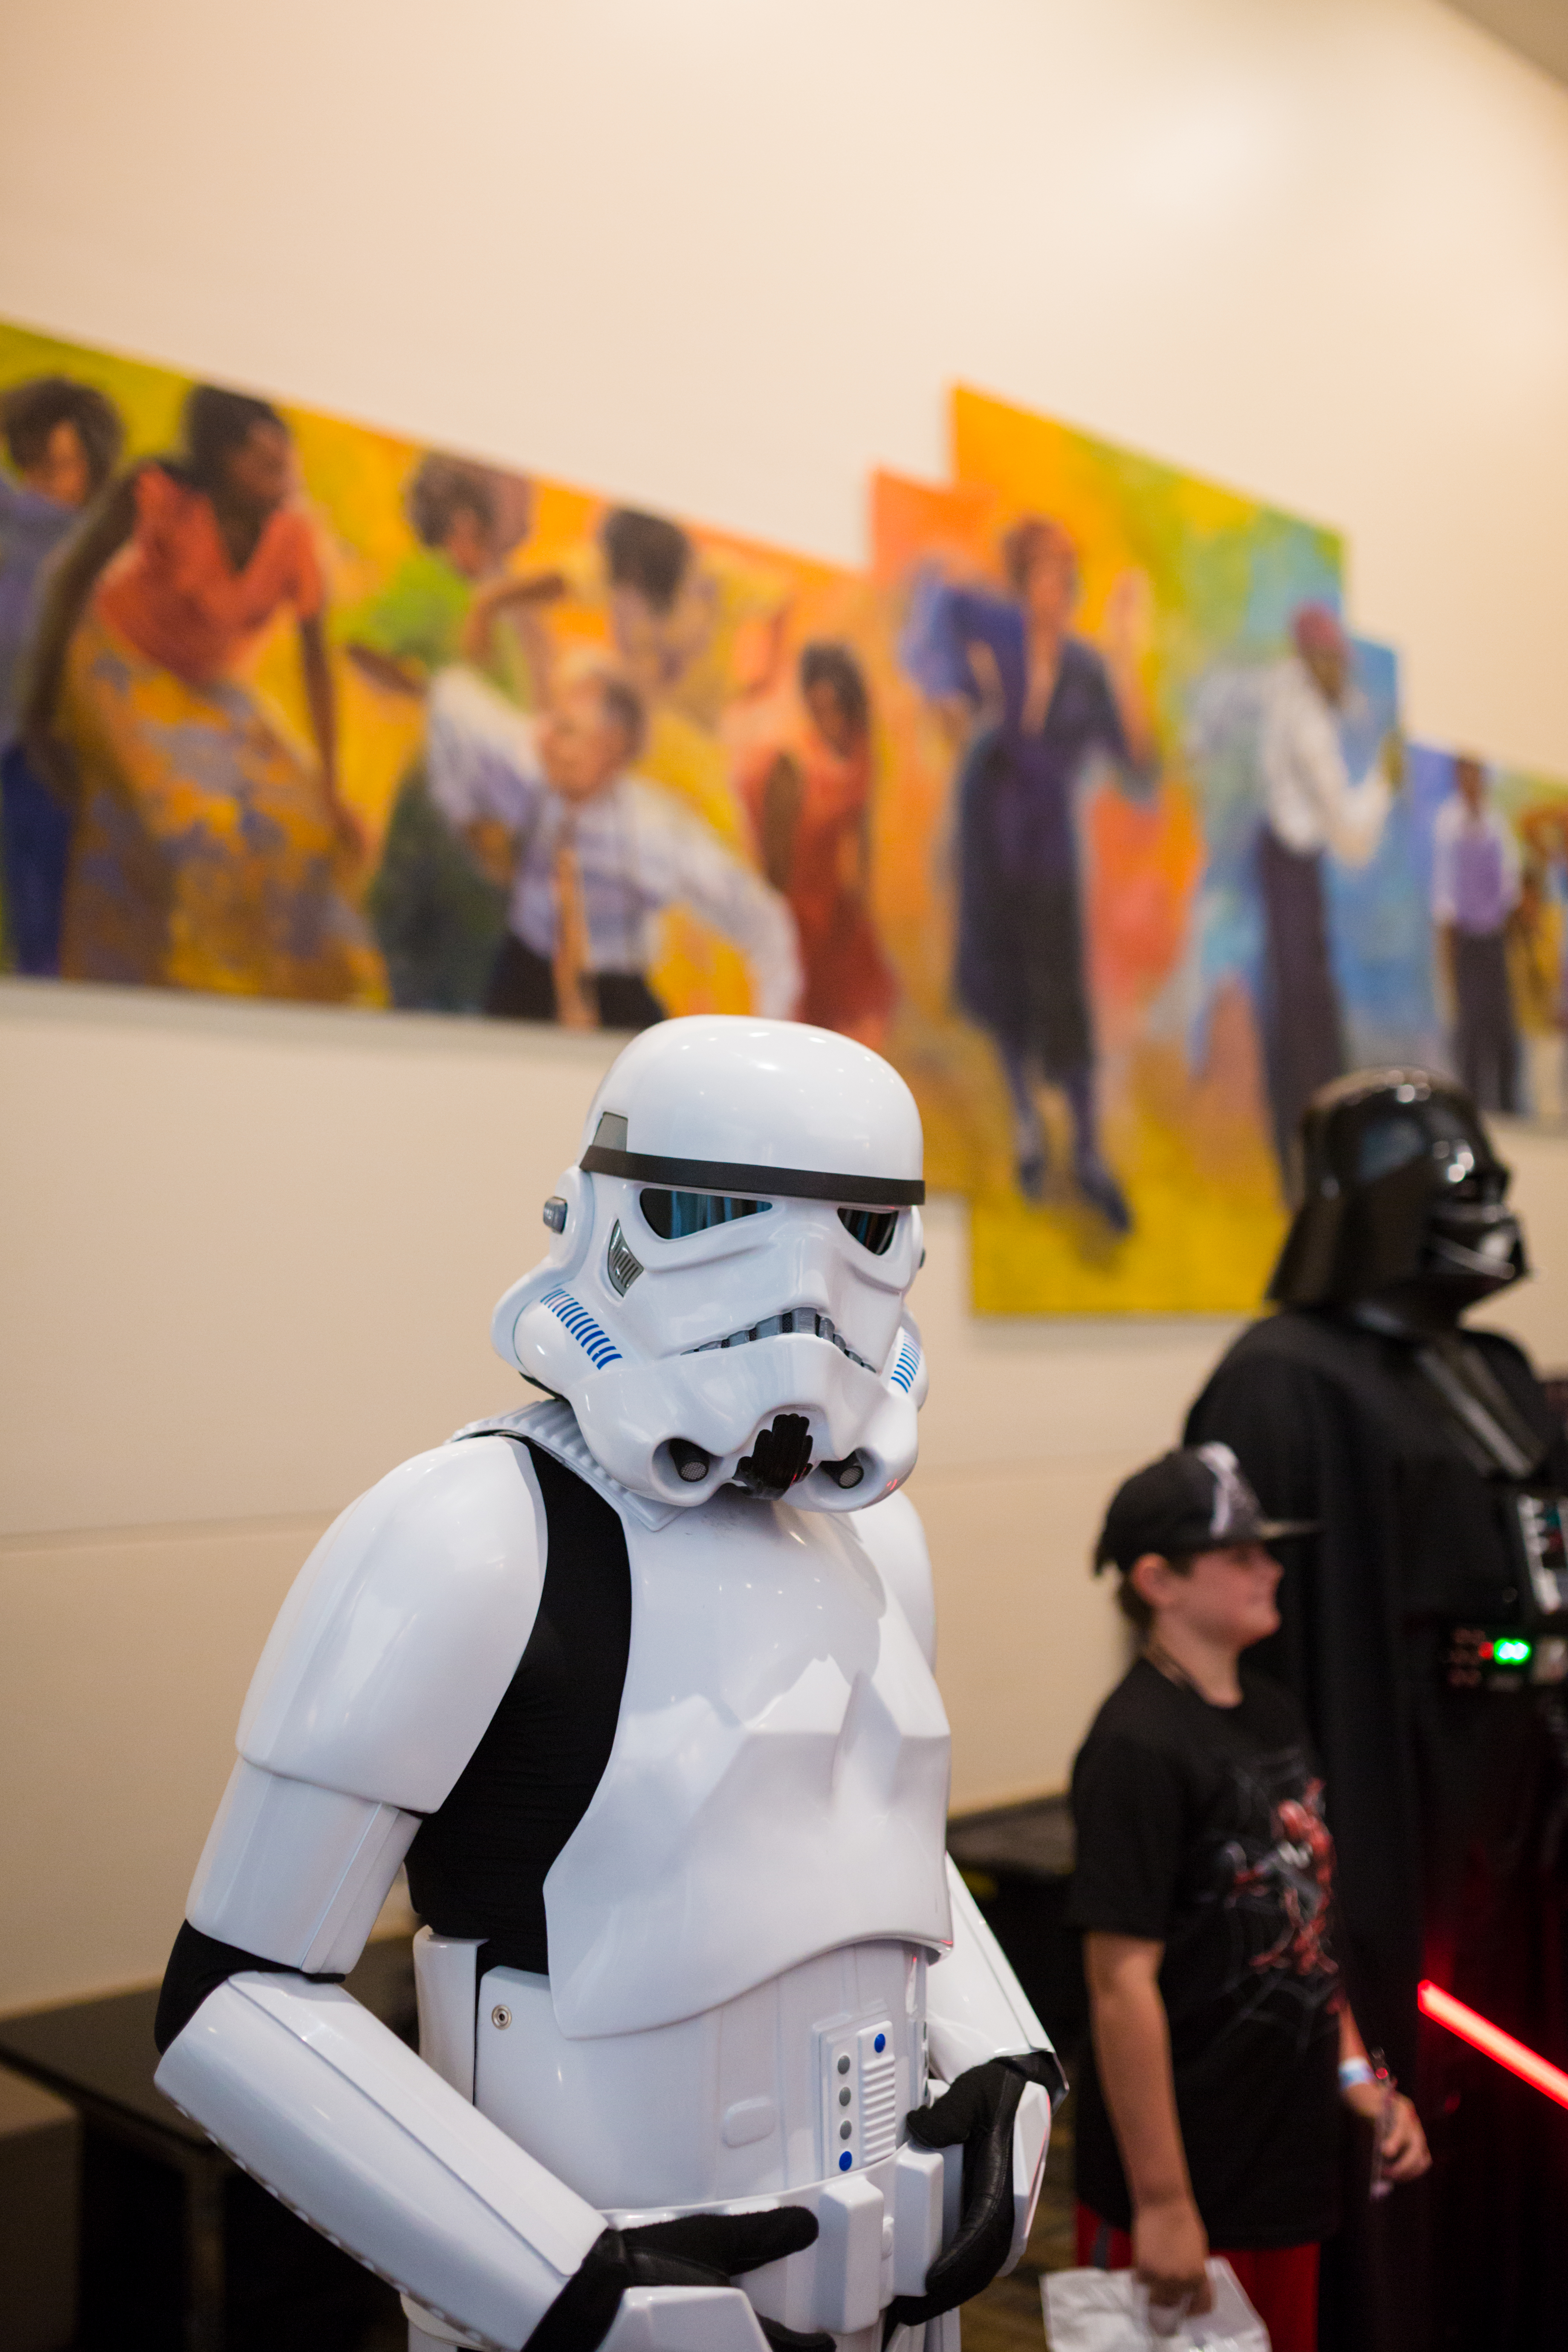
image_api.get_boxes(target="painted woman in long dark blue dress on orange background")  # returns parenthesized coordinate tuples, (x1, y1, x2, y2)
(903, 515, 1157, 1232)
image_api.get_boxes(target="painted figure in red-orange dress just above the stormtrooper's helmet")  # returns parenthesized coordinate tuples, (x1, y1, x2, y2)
(741, 645, 898, 1049)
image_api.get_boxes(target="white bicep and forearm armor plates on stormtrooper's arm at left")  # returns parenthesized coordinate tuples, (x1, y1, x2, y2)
(157, 1759, 604, 2352)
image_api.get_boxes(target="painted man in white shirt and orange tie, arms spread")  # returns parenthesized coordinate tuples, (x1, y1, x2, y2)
(428, 663, 799, 1028)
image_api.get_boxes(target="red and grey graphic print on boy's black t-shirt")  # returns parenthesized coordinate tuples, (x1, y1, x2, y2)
(1211, 1747, 1340, 2039)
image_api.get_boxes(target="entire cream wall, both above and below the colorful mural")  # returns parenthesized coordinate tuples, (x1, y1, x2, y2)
(0, 0, 1568, 2004)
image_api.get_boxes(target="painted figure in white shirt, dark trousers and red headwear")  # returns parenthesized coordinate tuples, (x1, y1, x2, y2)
(1258, 605, 1401, 1171)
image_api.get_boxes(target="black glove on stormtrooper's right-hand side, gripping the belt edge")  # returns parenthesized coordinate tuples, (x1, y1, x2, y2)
(884, 2051, 1065, 2340)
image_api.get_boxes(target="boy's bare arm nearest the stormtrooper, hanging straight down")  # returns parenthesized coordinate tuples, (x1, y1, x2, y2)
(1084, 1929, 1211, 2312)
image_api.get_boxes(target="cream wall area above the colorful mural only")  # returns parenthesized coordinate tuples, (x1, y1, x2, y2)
(0, 0, 1568, 769)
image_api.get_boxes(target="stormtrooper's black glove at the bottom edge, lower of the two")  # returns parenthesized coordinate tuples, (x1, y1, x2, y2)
(527, 2206, 832, 2352)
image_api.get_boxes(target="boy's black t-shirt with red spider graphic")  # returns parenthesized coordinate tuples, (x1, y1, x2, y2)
(1070, 1658, 1340, 2246)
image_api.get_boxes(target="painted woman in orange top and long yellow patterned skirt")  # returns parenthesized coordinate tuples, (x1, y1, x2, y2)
(23, 386, 385, 1004)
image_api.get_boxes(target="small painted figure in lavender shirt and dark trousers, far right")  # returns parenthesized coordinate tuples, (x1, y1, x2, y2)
(1432, 755, 1523, 1110)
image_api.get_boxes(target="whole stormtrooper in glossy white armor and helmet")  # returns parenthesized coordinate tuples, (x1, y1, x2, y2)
(157, 1018, 1060, 2352)
